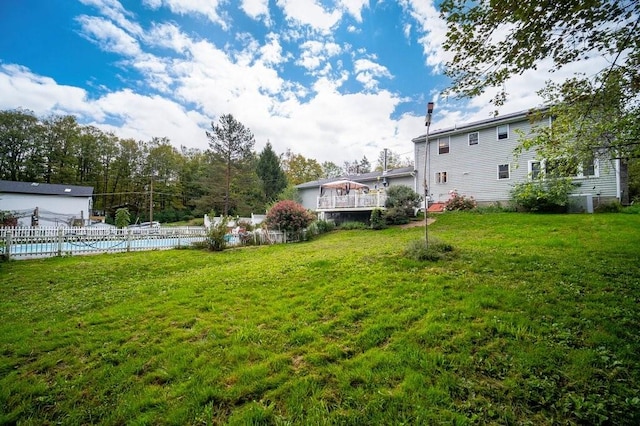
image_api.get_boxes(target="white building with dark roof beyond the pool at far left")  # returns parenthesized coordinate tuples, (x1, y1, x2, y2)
(0, 180, 93, 226)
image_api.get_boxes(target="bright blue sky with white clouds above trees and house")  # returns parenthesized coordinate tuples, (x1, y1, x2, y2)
(0, 0, 596, 165)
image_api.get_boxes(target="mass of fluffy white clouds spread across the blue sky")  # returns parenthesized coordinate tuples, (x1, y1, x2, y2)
(7, 0, 592, 164)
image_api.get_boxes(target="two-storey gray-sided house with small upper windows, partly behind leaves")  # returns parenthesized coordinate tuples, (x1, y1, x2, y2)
(413, 111, 624, 211)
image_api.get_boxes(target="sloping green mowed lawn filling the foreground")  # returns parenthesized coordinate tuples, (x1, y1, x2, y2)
(0, 213, 640, 425)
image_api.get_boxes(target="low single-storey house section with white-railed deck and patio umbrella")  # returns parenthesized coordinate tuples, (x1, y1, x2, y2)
(296, 167, 418, 222)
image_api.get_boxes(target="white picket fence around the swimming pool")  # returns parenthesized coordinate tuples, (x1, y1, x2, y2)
(0, 226, 286, 259)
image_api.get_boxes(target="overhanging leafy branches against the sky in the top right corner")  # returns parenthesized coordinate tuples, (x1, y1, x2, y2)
(441, 0, 640, 105)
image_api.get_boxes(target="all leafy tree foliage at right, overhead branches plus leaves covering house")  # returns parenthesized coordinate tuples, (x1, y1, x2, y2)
(441, 0, 640, 205)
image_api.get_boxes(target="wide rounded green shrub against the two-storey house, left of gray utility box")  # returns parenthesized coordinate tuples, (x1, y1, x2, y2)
(511, 178, 575, 213)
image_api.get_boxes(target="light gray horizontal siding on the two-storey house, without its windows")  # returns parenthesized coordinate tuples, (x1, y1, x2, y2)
(413, 113, 618, 203)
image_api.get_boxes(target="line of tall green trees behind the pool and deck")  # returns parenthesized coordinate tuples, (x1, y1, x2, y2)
(0, 109, 410, 222)
